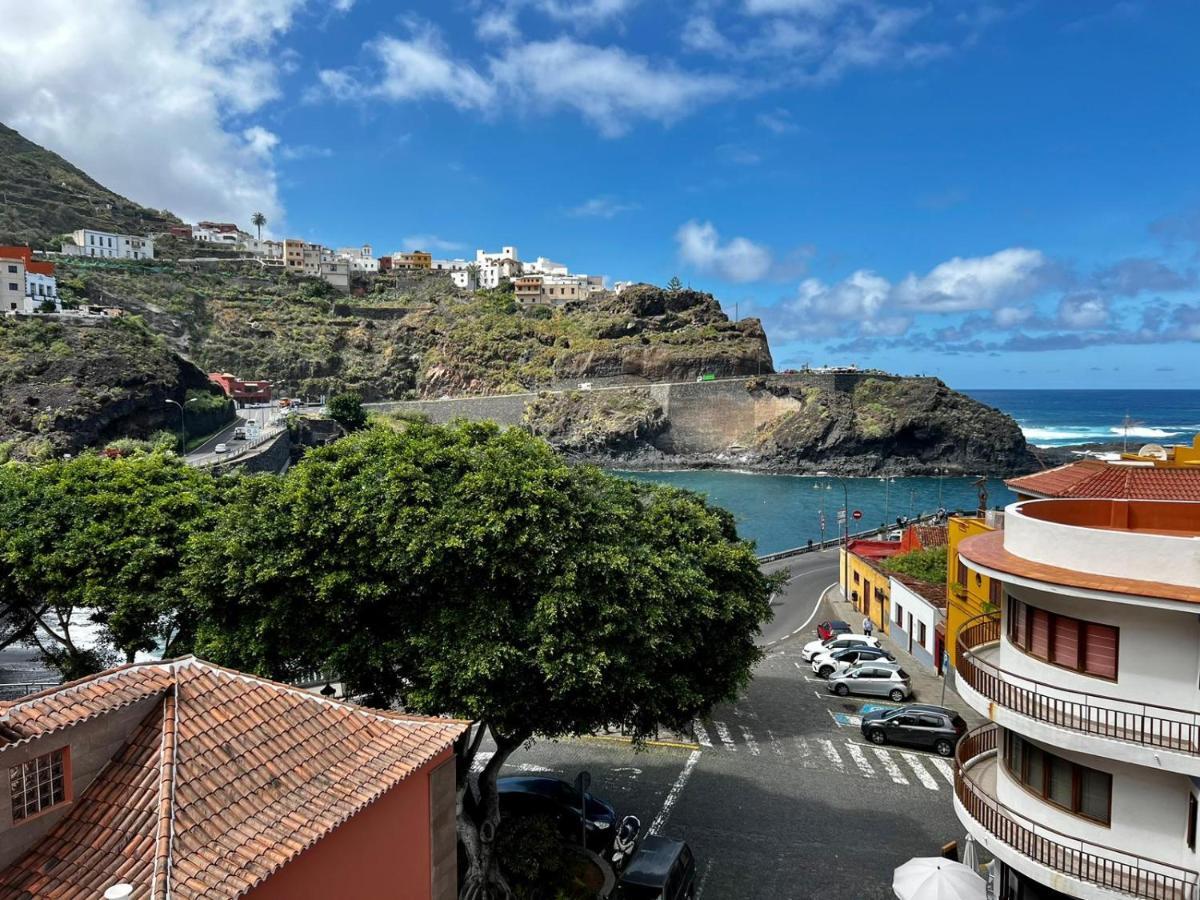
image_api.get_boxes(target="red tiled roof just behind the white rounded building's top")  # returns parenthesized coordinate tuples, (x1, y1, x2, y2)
(1004, 460, 1200, 500)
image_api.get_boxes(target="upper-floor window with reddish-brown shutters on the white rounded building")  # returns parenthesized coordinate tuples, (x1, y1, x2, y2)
(1008, 598, 1120, 680)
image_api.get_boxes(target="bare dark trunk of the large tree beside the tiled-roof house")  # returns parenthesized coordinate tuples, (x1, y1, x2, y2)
(457, 725, 530, 900)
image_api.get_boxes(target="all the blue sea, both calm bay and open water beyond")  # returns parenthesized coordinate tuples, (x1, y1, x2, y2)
(620, 390, 1200, 553)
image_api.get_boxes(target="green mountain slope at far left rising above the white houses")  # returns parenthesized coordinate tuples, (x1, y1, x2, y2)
(0, 124, 179, 250)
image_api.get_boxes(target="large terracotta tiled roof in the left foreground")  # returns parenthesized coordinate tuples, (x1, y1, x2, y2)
(0, 658, 467, 900)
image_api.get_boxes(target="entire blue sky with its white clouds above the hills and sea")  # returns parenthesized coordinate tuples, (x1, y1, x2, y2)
(0, 0, 1200, 388)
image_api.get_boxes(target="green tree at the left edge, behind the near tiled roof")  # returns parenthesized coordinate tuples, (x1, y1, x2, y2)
(0, 454, 215, 679)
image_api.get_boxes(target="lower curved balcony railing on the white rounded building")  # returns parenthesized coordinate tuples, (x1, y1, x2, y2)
(954, 725, 1198, 900)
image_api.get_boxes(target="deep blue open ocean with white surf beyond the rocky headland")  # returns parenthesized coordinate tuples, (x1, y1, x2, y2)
(964, 390, 1200, 449)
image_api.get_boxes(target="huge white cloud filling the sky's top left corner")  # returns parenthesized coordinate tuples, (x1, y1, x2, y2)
(0, 0, 319, 222)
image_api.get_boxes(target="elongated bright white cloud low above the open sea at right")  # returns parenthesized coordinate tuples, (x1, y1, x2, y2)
(893, 247, 1048, 312)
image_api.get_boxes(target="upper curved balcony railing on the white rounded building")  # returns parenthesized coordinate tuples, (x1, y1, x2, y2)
(954, 613, 1200, 755)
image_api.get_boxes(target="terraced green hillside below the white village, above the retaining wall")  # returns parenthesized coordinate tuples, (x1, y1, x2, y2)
(61, 264, 773, 401)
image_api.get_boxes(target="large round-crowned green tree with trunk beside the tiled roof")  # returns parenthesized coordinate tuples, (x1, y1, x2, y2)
(187, 424, 772, 898)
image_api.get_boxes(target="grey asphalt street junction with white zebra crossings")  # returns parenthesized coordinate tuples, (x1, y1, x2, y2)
(502, 588, 961, 900)
